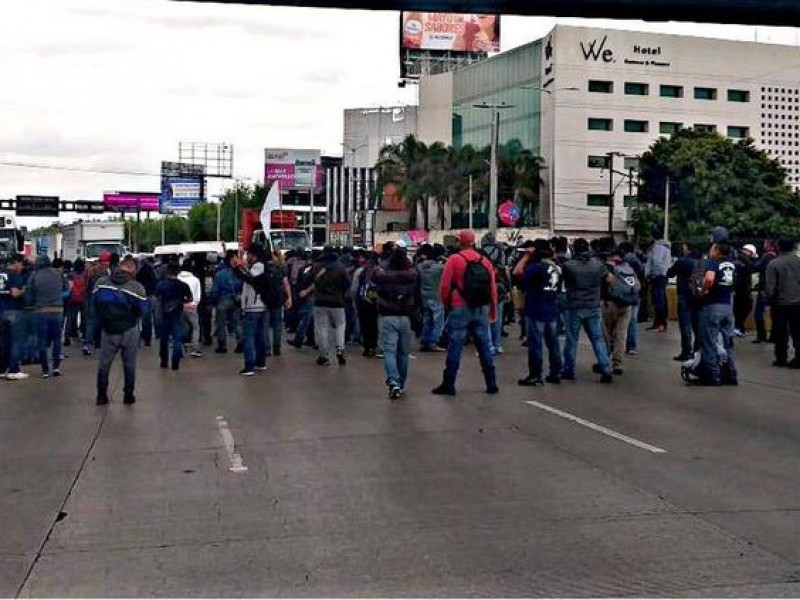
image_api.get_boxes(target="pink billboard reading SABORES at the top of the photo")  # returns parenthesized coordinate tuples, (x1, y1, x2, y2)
(400, 12, 500, 52)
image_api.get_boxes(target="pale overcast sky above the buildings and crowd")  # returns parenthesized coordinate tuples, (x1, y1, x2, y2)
(0, 0, 797, 225)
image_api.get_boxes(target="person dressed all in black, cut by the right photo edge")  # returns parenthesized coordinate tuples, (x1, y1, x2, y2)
(766, 238, 800, 369)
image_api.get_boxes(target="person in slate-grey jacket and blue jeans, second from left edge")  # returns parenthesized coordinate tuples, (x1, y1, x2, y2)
(25, 255, 69, 379)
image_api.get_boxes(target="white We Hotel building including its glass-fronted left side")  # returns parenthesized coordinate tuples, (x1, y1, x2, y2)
(417, 26, 800, 235)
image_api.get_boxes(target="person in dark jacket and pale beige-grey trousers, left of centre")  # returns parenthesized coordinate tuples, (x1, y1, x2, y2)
(314, 246, 350, 367)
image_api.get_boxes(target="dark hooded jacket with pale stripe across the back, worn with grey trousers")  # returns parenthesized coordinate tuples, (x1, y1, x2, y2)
(92, 269, 149, 335)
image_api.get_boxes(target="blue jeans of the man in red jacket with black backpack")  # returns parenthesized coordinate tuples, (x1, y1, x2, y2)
(444, 306, 497, 386)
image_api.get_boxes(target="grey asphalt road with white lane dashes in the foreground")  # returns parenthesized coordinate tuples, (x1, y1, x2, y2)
(0, 328, 800, 597)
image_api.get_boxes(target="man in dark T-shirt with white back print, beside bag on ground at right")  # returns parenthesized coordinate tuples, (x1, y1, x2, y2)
(692, 243, 738, 386)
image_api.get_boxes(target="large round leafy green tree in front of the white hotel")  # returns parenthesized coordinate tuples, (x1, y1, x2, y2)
(639, 129, 800, 239)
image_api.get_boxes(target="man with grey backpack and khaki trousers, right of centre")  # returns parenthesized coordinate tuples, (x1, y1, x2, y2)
(603, 248, 642, 375)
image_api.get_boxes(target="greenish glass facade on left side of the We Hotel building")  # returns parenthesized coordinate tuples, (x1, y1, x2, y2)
(453, 42, 542, 154)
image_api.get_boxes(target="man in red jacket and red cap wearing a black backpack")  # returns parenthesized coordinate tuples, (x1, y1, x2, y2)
(432, 230, 499, 396)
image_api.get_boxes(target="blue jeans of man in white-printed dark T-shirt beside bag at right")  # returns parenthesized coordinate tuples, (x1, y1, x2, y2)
(700, 304, 736, 383)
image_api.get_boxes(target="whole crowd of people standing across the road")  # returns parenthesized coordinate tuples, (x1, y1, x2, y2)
(0, 227, 800, 404)
